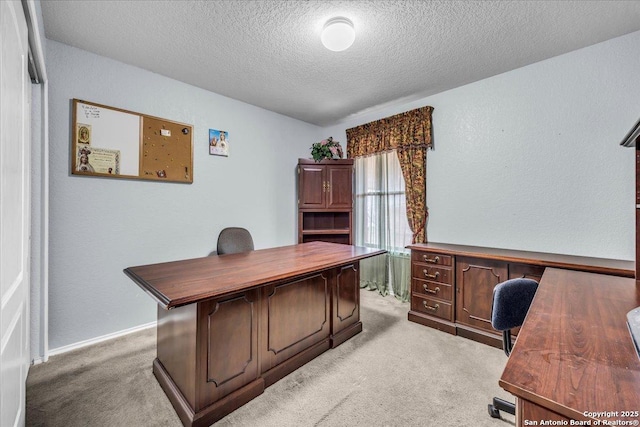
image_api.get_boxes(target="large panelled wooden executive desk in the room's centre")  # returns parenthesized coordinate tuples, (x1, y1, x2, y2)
(124, 242, 385, 426)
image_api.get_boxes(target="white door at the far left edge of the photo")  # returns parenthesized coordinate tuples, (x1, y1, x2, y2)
(0, 0, 31, 427)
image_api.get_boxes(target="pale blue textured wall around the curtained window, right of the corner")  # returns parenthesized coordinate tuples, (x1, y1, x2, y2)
(324, 32, 640, 260)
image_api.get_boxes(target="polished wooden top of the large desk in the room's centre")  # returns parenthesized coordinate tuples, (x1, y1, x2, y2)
(124, 242, 386, 308)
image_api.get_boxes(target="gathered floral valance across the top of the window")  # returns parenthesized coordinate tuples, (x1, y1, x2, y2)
(347, 107, 433, 158)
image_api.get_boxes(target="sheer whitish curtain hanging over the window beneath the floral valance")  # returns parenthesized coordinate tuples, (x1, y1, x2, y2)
(355, 151, 412, 301)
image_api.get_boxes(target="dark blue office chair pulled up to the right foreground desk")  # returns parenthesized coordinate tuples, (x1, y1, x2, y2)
(488, 279, 538, 418)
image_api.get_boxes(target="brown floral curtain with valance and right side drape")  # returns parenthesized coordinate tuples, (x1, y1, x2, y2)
(347, 107, 433, 243)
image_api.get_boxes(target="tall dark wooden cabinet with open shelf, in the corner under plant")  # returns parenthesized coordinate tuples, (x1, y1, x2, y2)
(298, 159, 353, 245)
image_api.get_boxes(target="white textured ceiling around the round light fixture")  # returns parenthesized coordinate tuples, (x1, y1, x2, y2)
(41, 0, 640, 126)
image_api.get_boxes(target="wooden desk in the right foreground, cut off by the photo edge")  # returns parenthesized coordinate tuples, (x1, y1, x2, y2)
(499, 268, 640, 426)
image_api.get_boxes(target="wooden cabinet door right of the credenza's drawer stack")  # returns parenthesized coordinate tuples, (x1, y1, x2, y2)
(456, 257, 509, 334)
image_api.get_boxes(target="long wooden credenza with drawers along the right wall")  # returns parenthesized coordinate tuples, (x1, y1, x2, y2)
(407, 243, 635, 348)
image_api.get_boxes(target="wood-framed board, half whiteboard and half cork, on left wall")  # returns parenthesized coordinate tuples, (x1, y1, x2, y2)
(71, 99, 193, 183)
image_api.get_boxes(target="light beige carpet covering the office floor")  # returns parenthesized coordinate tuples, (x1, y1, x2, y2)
(26, 290, 514, 427)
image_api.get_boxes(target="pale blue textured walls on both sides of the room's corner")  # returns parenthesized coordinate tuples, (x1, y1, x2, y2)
(45, 32, 640, 349)
